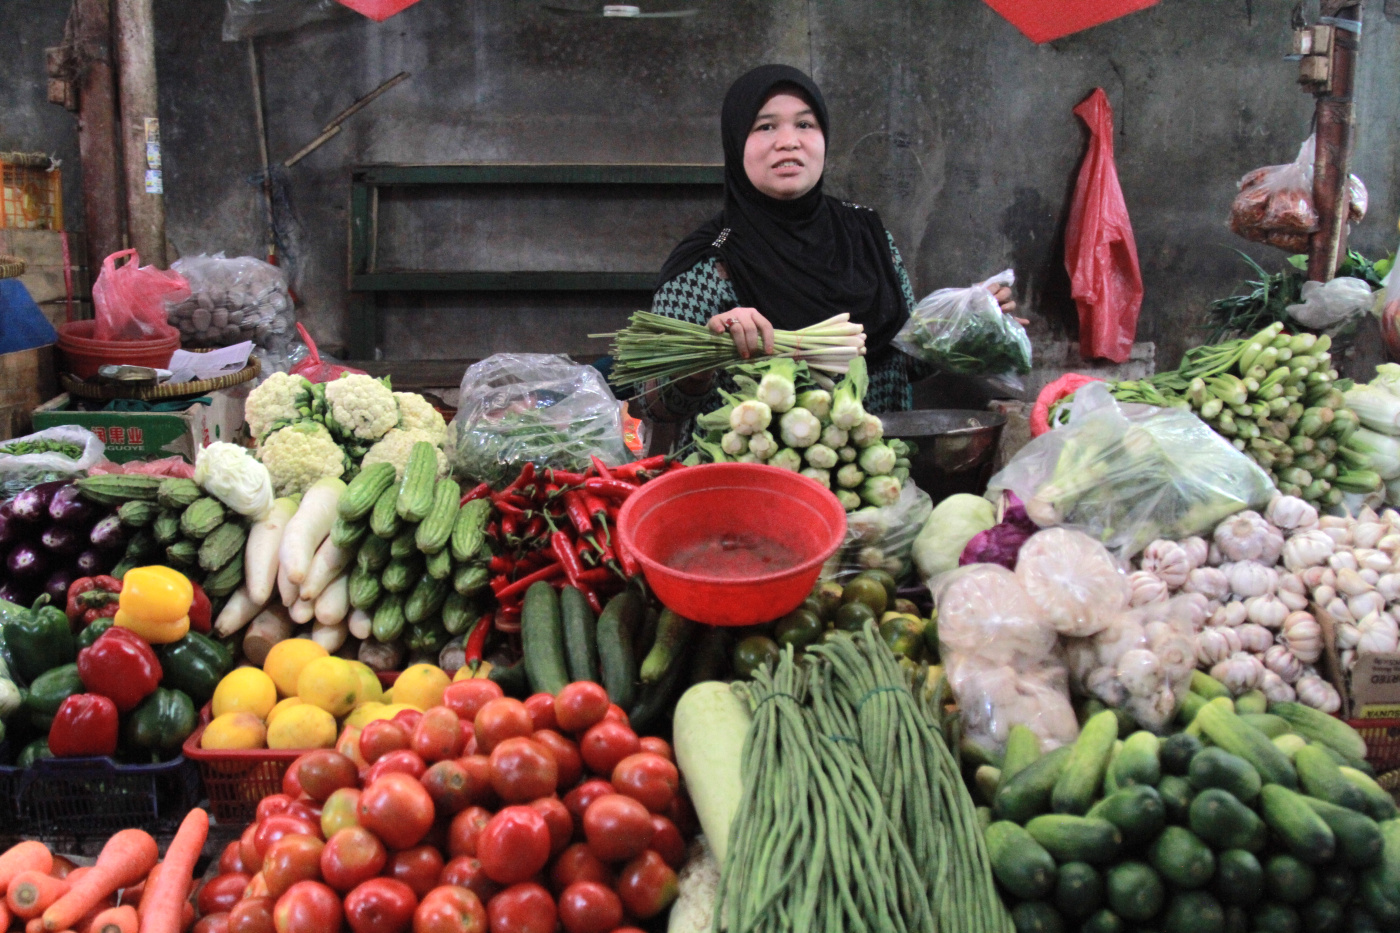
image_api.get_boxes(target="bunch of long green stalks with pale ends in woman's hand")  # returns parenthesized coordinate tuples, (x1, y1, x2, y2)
(589, 311, 865, 385)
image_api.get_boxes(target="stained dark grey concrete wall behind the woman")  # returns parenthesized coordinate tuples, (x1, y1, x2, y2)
(0, 0, 1400, 375)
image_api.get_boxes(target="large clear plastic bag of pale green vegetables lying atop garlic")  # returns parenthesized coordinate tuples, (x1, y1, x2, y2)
(988, 382, 1277, 559)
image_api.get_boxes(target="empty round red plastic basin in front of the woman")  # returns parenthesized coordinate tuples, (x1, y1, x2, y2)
(617, 464, 846, 625)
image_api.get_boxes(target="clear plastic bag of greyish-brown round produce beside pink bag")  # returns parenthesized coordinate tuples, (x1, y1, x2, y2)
(167, 252, 297, 349)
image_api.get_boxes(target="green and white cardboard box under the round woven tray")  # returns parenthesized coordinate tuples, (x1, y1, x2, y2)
(34, 387, 248, 464)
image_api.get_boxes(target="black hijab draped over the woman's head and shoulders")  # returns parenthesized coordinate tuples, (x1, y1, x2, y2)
(661, 64, 909, 356)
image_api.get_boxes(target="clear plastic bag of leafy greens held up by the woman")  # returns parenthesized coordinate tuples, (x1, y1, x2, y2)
(895, 269, 1030, 382)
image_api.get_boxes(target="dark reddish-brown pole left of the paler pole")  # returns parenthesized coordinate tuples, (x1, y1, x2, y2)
(76, 0, 123, 280)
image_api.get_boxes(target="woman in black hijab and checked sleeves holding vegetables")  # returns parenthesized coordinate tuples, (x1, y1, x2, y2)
(637, 64, 1015, 443)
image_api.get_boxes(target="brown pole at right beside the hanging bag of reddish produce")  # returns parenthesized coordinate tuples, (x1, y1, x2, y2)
(1308, 0, 1361, 282)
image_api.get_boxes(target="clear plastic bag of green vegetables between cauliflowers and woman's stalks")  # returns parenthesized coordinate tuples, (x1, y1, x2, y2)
(449, 353, 633, 485)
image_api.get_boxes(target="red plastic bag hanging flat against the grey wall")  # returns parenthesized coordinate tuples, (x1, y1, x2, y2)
(1064, 87, 1142, 363)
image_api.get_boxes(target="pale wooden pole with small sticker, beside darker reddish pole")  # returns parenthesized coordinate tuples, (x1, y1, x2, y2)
(113, 0, 165, 269)
